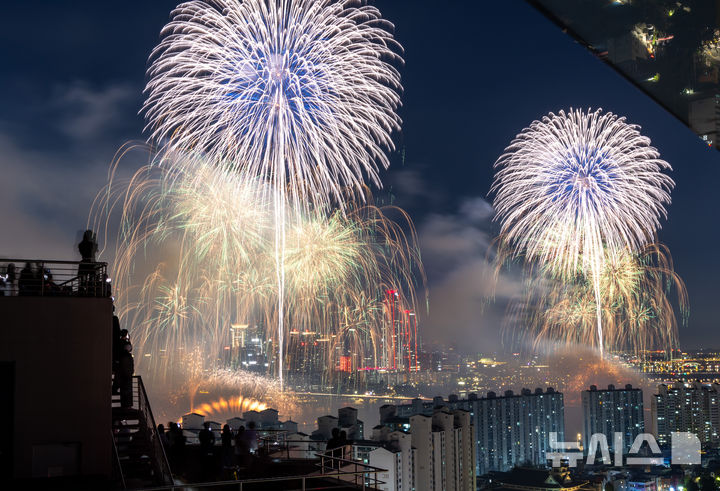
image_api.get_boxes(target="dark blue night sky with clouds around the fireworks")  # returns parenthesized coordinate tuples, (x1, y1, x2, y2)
(0, 0, 720, 351)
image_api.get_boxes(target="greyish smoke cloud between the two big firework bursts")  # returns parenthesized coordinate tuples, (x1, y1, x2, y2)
(418, 197, 522, 352)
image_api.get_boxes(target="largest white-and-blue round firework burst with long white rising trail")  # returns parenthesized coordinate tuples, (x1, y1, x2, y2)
(143, 0, 402, 388)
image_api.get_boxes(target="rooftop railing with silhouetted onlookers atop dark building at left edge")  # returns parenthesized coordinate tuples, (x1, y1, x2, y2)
(0, 259, 112, 297)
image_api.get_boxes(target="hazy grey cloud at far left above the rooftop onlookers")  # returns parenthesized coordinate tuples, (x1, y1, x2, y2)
(0, 82, 145, 259)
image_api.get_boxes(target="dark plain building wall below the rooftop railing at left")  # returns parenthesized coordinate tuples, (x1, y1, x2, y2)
(0, 297, 113, 479)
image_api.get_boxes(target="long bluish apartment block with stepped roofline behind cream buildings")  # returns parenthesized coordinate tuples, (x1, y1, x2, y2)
(380, 388, 565, 475)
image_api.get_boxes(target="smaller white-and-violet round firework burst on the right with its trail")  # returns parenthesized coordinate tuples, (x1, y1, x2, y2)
(491, 109, 674, 352)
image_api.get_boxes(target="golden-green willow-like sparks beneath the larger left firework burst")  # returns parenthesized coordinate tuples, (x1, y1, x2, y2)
(95, 153, 425, 400)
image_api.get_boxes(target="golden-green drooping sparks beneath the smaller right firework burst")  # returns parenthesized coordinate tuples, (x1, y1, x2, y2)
(510, 244, 688, 354)
